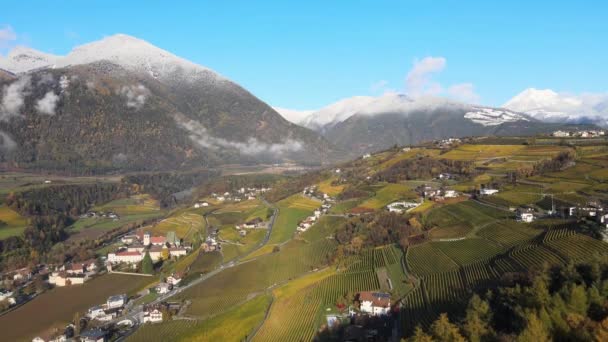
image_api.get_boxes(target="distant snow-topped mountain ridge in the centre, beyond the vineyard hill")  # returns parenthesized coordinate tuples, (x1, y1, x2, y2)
(304, 93, 588, 154)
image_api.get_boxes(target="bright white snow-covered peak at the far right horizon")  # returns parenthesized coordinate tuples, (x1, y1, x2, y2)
(503, 88, 608, 127)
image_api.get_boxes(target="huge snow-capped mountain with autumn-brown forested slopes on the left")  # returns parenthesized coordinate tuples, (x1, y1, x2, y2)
(0, 35, 330, 172)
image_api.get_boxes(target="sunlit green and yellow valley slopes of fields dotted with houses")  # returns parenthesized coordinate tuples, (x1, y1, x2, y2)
(0, 132, 608, 341)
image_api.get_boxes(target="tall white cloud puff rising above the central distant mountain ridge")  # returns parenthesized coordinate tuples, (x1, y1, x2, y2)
(405, 56, 446, 96)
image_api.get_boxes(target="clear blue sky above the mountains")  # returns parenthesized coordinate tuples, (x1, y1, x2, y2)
(0, 0, 608, 109)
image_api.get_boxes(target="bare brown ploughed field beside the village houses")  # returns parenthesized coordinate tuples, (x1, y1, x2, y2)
(0, 274, 156, 341)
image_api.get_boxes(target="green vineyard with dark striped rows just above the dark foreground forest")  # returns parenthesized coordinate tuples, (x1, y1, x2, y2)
(400, 227, 608, 334)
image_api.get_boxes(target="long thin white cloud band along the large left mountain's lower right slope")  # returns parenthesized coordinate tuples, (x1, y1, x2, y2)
(176, 118, 303, 155)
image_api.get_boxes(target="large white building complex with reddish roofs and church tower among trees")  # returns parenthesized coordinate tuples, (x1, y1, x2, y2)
(107, 231, 192, 269)
